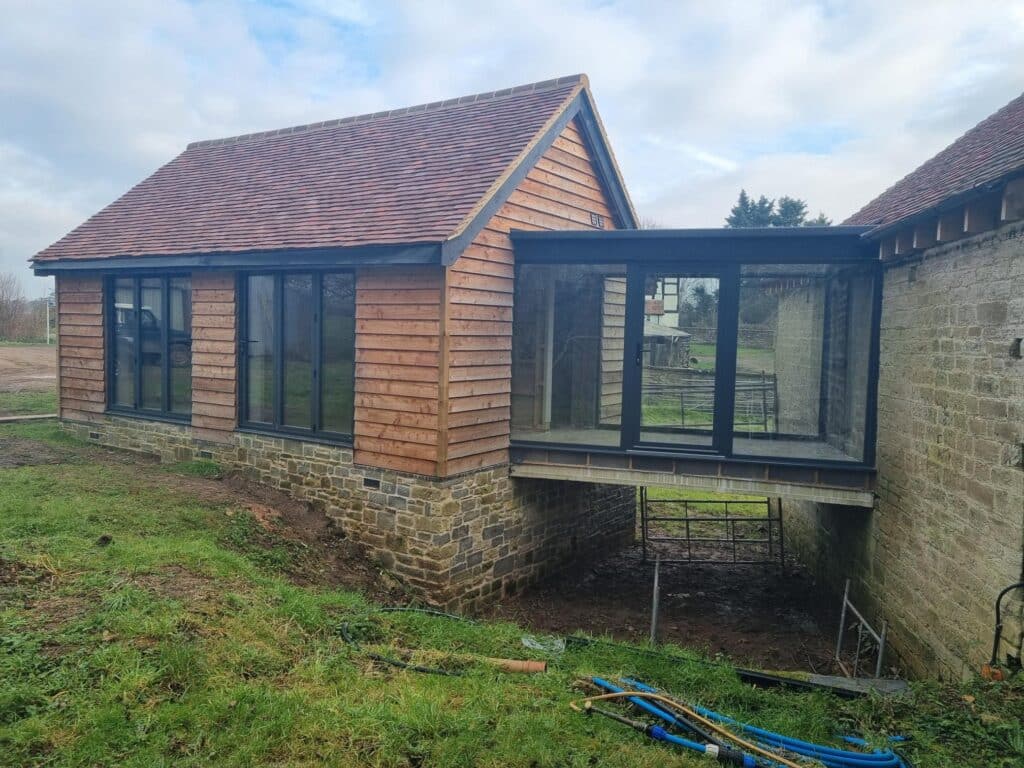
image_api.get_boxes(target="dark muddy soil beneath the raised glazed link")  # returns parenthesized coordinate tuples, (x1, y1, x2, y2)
(490, 546, 838, 674)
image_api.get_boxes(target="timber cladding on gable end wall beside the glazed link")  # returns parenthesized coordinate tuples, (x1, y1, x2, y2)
(438, 123, 614, 476)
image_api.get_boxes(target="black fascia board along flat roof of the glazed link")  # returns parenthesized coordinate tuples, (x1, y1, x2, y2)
(511, 226, 878, 264)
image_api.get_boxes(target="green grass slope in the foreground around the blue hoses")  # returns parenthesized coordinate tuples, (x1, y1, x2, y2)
(0, 422, 1024, 768)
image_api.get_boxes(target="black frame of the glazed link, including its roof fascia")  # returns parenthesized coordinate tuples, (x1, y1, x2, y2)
(511, 226, 883, 470)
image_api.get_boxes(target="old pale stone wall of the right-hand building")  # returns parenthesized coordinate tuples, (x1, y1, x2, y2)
(786, 223, 1024, 678)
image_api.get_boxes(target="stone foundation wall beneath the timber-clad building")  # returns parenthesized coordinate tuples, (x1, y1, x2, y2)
(65, 416, 636, 610)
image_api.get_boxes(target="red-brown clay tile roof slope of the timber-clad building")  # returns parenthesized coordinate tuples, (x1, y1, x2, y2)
(35, 75, 587, 262)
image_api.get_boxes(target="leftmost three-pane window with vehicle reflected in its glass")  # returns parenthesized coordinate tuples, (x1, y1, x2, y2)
(106, 276, 191, 419)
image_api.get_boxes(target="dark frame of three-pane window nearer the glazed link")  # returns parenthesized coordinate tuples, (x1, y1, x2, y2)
(236, 268, 355, 446)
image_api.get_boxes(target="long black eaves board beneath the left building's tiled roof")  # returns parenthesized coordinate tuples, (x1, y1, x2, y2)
(32, 243, 441, 276)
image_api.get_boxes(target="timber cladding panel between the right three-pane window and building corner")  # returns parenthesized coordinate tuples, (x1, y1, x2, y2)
(353, 267, 443, 475)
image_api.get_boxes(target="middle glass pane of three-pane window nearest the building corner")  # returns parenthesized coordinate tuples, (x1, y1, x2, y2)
(282, 274, 313, 429)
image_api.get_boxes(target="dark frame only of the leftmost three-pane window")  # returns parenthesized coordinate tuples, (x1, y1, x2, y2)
(103, 272, 193, 424)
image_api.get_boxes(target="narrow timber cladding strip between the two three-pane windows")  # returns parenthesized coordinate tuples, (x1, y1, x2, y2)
(191, 272, 238, 442)
